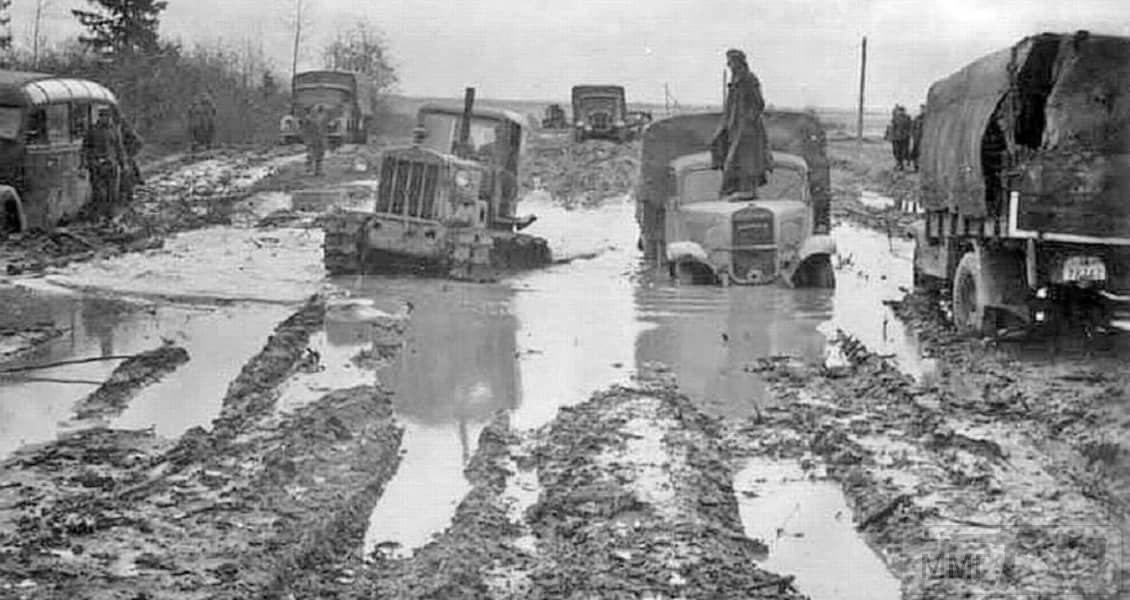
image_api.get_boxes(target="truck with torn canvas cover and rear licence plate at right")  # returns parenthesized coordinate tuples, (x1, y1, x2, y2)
(914, 32, 1130, 334)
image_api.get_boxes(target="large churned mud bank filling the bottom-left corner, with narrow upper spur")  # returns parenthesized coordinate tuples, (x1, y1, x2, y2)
(0, 298, 401, 599)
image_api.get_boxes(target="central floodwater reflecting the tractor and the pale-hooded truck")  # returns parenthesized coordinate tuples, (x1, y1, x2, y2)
(357, 194, 915, 556)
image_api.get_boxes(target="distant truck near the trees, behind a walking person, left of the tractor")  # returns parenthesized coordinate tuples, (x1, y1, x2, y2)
(279, 71, 374, 146)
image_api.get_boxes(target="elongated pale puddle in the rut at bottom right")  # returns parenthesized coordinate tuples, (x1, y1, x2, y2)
(733, 460, 902, 600)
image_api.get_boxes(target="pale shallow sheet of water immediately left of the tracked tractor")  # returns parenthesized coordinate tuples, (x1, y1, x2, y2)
(33, 227, 325, 303)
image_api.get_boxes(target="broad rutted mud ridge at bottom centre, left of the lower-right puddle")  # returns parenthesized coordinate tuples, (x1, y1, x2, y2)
(519, 389, 800, 598)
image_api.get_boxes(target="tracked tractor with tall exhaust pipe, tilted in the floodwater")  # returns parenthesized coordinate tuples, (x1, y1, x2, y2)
(323, 88, 550, 280)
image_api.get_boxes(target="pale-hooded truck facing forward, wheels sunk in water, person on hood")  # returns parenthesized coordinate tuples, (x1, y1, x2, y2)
(636, 112, 835, 287)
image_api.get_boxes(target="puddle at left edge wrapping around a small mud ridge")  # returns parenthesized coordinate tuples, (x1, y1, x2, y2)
(0, 298, 289, 458)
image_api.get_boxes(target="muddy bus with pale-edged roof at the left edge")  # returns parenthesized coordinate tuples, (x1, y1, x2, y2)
(0, 70, 118, 233)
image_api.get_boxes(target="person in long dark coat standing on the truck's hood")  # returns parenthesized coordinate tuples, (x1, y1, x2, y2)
(711, 50, 771, 199)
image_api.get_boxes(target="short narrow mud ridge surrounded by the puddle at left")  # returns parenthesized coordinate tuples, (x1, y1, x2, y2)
(75, 345, 189, 419)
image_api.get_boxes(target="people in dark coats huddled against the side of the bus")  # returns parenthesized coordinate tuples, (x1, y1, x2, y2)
(82, 106, 142, 217)
